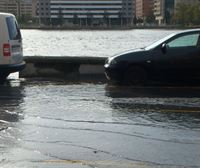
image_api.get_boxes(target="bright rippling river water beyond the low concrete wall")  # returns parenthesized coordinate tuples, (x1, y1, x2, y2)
(22, 29, 178, 57)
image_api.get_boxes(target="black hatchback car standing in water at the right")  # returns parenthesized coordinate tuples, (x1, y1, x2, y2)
(104, 29, 200, 85)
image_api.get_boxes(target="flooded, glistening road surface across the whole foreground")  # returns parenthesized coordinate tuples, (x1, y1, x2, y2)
(0, 79, 200, 168)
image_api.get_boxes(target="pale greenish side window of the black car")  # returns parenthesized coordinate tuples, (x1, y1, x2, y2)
(167, 33, 199, 48)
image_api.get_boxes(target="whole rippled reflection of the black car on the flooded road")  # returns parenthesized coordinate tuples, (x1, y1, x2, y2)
(105, 85, 200, 129)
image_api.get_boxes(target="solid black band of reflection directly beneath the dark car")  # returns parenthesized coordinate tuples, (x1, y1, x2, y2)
(105, 85, 200, 98)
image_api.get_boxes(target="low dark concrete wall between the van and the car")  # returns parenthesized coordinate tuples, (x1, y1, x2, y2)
(19, 56, 106, 79)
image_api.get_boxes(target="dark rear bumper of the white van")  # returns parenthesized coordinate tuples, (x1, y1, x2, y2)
(0, 61, 26, 74)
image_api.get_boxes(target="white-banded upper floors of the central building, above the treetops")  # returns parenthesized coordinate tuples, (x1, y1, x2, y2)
(50, 0, 122, 18)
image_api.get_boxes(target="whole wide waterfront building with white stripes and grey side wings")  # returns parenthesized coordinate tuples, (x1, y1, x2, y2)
(37, 0, 135, 24)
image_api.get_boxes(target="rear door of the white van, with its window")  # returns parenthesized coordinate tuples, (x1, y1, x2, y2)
(4, 16, 23, 64)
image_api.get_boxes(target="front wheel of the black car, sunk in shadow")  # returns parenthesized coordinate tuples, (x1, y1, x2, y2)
(124, 66, 146, 86)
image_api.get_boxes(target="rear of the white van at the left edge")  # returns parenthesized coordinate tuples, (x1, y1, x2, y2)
(0, 13, 25, 81)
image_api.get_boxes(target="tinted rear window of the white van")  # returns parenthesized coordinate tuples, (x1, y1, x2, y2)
(6, 16, 21, 40)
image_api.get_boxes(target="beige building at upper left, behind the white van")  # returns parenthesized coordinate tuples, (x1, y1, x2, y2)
(0, 0, 36, 17)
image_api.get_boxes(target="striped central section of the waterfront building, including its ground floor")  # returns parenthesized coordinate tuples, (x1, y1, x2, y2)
(50, 0, 122, 25)
